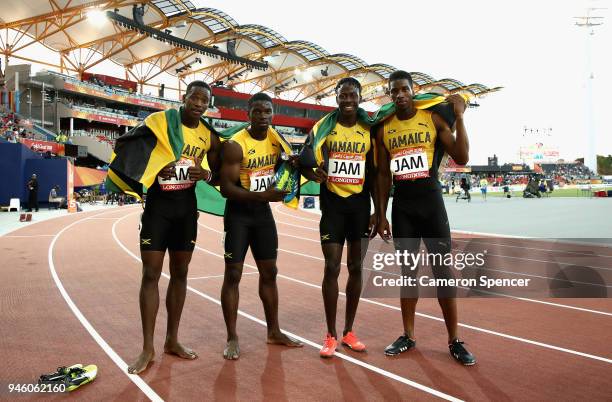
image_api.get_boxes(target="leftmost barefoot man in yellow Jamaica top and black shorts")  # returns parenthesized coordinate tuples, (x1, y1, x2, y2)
(128, 81, 221, 374)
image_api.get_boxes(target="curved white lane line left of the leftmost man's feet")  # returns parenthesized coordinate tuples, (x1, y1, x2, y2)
(48, 211, 163, 401)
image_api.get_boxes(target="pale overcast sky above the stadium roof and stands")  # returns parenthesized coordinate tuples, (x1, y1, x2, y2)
(192, 0, 612, 164)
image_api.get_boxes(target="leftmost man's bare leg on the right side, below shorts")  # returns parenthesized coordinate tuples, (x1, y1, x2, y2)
(164, 251, 198, 359)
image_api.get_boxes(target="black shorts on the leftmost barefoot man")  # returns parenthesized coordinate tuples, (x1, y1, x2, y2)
(140, 195, 198, 251)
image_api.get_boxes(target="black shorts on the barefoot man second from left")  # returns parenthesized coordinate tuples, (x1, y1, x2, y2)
(223, 201, 278, 263)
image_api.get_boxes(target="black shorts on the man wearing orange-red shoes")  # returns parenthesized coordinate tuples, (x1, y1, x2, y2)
(319, 185, 370, 244)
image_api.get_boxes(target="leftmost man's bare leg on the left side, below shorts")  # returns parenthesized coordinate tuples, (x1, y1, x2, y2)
(128, 251, 165, 374)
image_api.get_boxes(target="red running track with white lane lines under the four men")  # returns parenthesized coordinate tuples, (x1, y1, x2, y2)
(0, 207, 612, 401)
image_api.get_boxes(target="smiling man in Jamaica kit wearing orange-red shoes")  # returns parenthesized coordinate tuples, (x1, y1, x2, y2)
(303, 78, 375, 357)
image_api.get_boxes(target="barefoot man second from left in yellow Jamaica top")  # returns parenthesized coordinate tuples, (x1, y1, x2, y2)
(220, 93, 302, 360)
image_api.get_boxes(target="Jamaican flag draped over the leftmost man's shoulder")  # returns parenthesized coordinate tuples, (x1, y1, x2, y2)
(106, 109, 216, 199)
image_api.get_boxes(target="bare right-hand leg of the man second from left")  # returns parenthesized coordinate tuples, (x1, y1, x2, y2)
(255, 259, 302, 346)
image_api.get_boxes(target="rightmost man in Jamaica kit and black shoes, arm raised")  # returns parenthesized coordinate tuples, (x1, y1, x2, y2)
(376, 71, 476, 365)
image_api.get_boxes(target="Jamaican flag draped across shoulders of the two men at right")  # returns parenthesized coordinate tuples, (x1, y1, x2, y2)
(300, 93, 467, 168)
